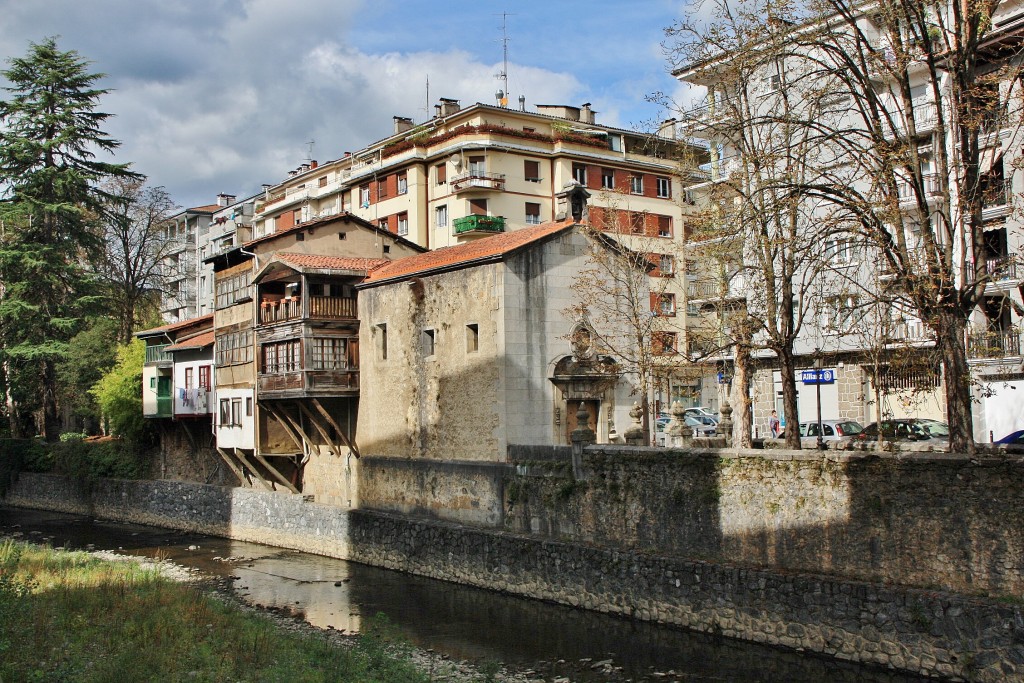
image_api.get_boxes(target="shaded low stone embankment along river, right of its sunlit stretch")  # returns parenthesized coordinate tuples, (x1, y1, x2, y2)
(350, 510, 1024, 682)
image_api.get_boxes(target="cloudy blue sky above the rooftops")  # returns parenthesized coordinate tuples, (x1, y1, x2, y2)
(0, 0, 687, 208)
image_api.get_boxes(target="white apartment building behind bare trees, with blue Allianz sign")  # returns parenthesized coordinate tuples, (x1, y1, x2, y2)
(676, 3, 1024, 441)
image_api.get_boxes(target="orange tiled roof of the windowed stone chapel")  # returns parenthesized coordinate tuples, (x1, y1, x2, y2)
(366, 219, 575, 284)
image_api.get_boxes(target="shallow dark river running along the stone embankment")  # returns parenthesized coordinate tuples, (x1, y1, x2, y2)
(0, 507, 931, 683)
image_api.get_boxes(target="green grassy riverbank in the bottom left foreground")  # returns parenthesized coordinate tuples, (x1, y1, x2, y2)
(0, 541, 429, 683)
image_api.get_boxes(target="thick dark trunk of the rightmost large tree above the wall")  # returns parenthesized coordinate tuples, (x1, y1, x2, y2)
(936, 312, 975, 455)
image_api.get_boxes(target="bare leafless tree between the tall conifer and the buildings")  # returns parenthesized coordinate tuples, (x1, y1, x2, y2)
(97, 179, 178, 342)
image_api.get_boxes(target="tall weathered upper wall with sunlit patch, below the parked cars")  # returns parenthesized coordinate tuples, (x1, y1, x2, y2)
(505, 445, 1024, 597)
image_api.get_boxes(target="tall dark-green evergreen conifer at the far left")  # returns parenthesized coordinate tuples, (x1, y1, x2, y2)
(0, 38, 138, 440)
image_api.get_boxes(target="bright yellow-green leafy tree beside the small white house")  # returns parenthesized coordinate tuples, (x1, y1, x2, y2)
(89, 339, 150, 445)
